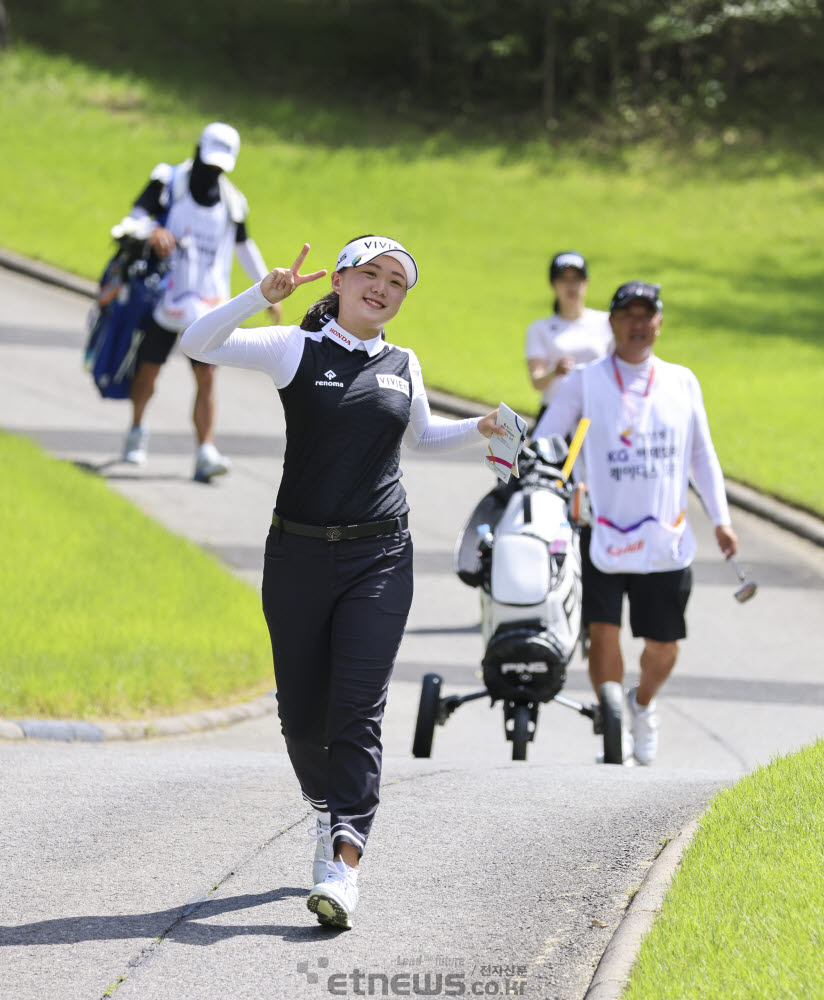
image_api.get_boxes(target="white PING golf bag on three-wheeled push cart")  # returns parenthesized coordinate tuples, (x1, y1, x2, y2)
(412, 427, 628, 764)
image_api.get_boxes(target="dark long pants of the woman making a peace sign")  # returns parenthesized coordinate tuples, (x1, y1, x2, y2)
(263, 526, 412, 853)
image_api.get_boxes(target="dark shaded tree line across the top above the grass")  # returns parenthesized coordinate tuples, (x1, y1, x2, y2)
(11, 0, 824, 129)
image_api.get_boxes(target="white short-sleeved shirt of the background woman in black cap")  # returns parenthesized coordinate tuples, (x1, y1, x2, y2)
(526, 309, 613, 406)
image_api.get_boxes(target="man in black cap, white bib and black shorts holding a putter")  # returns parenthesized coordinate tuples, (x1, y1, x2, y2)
(533, 281, 738, 764)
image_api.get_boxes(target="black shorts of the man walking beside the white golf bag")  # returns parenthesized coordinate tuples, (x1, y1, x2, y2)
(581, 530, 692, 642)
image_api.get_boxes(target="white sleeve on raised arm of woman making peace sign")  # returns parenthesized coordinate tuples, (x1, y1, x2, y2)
(180, 283, 306, 389)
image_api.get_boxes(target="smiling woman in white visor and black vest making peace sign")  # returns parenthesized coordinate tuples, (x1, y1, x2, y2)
(181, 236, 497, 928)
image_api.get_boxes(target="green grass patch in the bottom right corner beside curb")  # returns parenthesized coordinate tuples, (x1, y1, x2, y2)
(624, 740, 824, 1000)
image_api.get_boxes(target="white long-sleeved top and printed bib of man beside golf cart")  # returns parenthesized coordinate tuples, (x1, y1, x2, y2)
(533, 355, 730, 573)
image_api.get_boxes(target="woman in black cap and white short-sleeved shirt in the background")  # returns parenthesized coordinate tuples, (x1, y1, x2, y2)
(526, 250, 612, 420)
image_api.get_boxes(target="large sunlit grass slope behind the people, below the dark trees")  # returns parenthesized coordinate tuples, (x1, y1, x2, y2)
(0, 46, 824, 512)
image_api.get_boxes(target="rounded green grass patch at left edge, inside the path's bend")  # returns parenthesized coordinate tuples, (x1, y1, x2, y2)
(0, 432, 273, 719)
